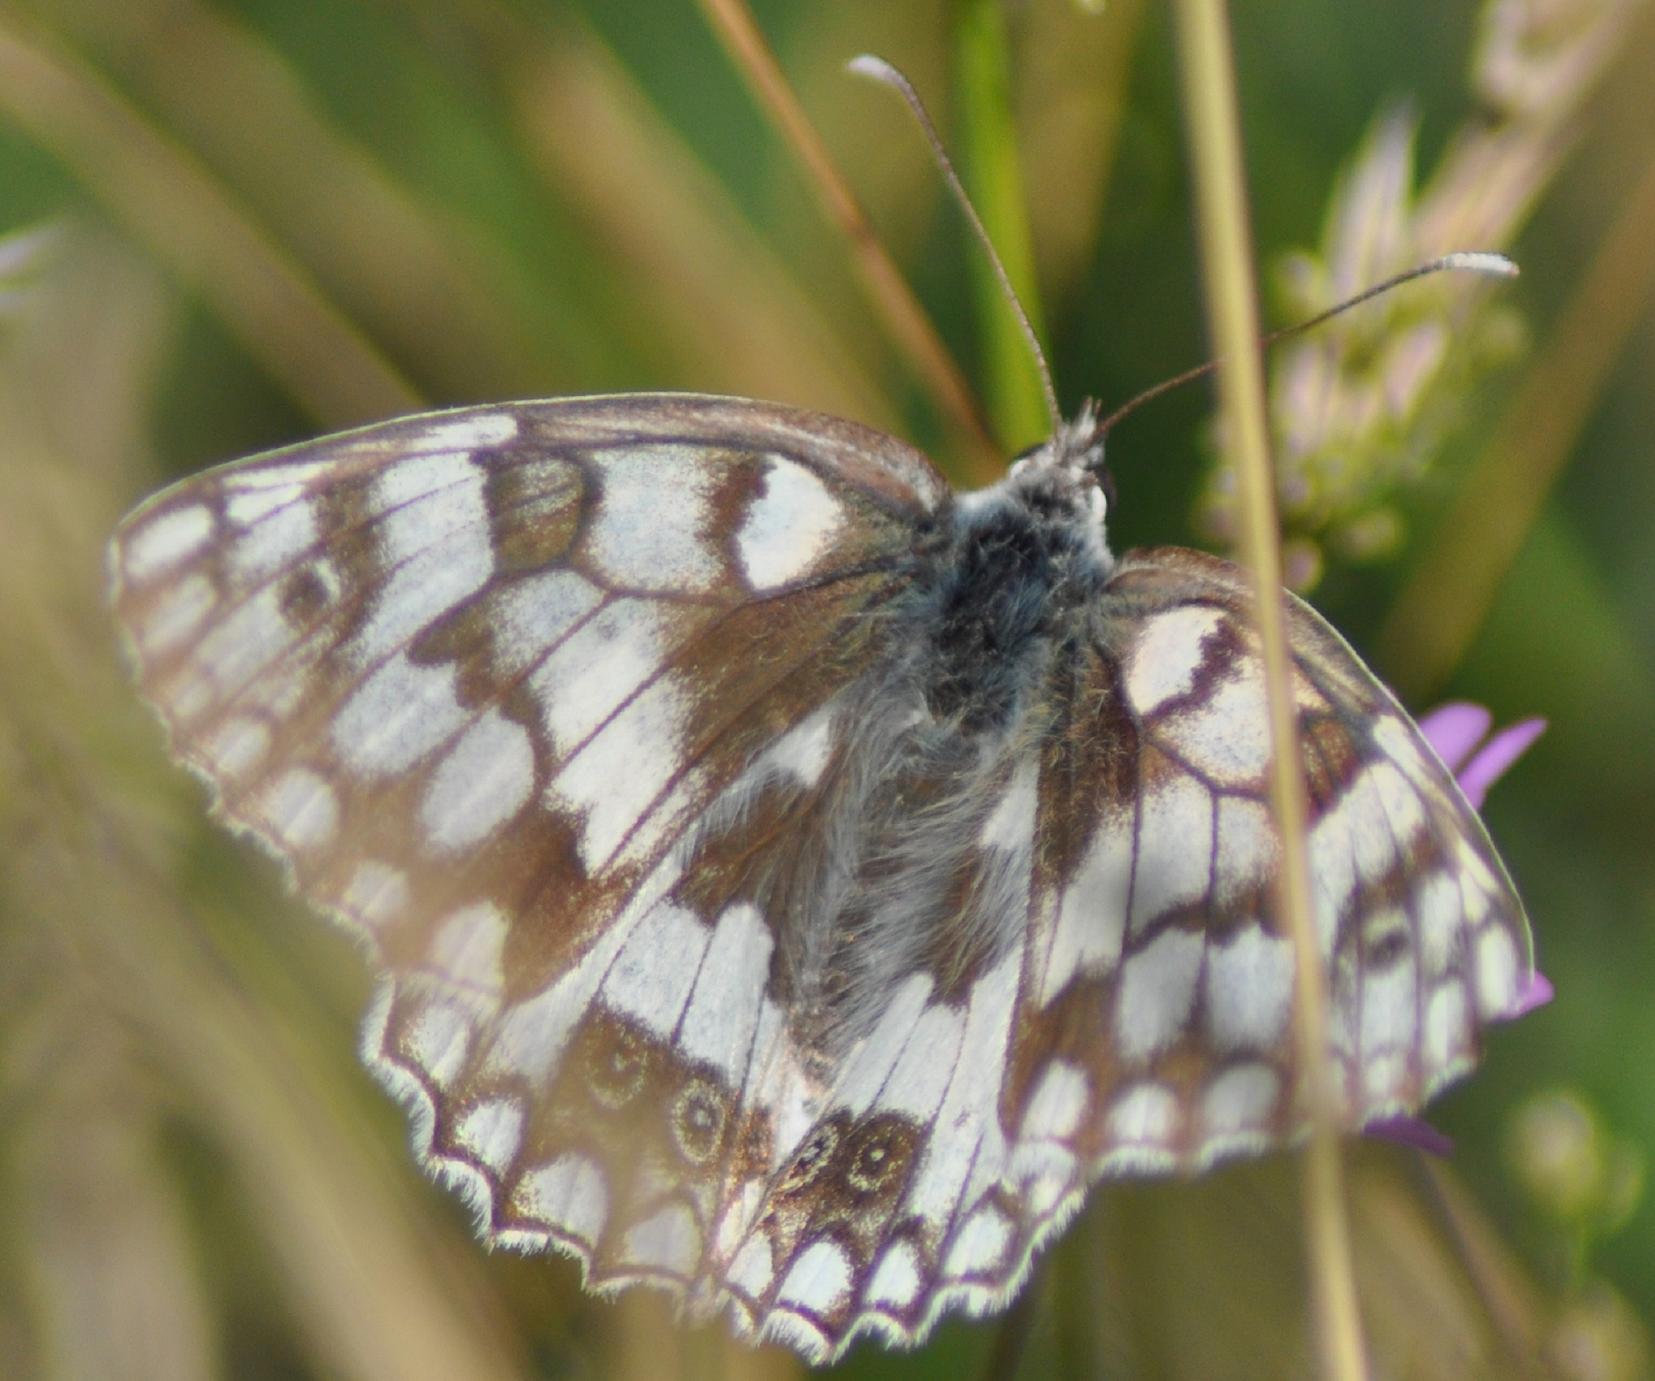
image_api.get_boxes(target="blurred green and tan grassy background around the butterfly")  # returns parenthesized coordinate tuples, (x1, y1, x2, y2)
(0, 0, 1655, 1378)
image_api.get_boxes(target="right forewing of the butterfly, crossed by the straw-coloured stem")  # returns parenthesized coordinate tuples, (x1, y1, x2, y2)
(986, 550, 1533, 1174)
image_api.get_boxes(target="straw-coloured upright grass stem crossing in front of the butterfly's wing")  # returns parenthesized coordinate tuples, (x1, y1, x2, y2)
(1175, 0, 1367, 1381)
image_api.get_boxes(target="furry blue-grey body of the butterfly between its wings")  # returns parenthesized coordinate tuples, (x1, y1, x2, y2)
(743, 420, 1114, 1066)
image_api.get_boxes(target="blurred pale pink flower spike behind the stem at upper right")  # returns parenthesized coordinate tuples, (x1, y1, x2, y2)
(1200, 0, 1640, 589)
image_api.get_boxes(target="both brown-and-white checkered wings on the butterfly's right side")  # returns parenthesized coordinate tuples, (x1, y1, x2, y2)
(678, 550, 1533, 1358)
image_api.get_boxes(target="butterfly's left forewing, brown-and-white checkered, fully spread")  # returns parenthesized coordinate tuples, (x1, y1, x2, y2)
(114, 399, 930, 940)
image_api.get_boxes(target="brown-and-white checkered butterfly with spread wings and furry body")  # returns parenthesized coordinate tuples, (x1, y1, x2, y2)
(111, 394, 1533, 1361)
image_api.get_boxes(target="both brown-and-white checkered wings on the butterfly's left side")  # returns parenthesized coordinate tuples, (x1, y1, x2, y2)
(111, 397, 945, 1337)
